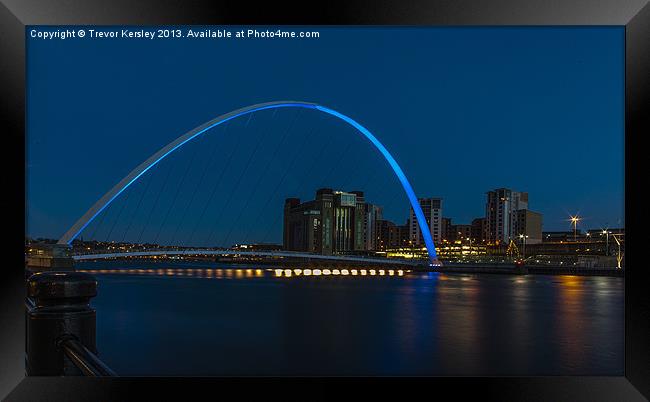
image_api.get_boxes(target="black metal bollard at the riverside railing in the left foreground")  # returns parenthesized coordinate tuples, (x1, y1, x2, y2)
(25, 271, 97, 376)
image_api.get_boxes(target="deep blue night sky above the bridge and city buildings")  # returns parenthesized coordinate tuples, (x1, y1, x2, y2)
(27, 27, 624, 243)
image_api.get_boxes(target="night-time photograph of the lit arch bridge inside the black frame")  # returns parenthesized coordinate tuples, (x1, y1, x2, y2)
(25, 26, 625, 376)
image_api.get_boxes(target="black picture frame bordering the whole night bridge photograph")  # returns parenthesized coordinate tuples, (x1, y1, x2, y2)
(0, 0, 650, 401)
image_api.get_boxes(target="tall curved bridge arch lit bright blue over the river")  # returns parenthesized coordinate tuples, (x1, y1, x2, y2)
(58, 101, 437, 263)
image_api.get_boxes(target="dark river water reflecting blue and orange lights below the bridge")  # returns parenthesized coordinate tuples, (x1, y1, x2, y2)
(78, 261, 624, 376)
